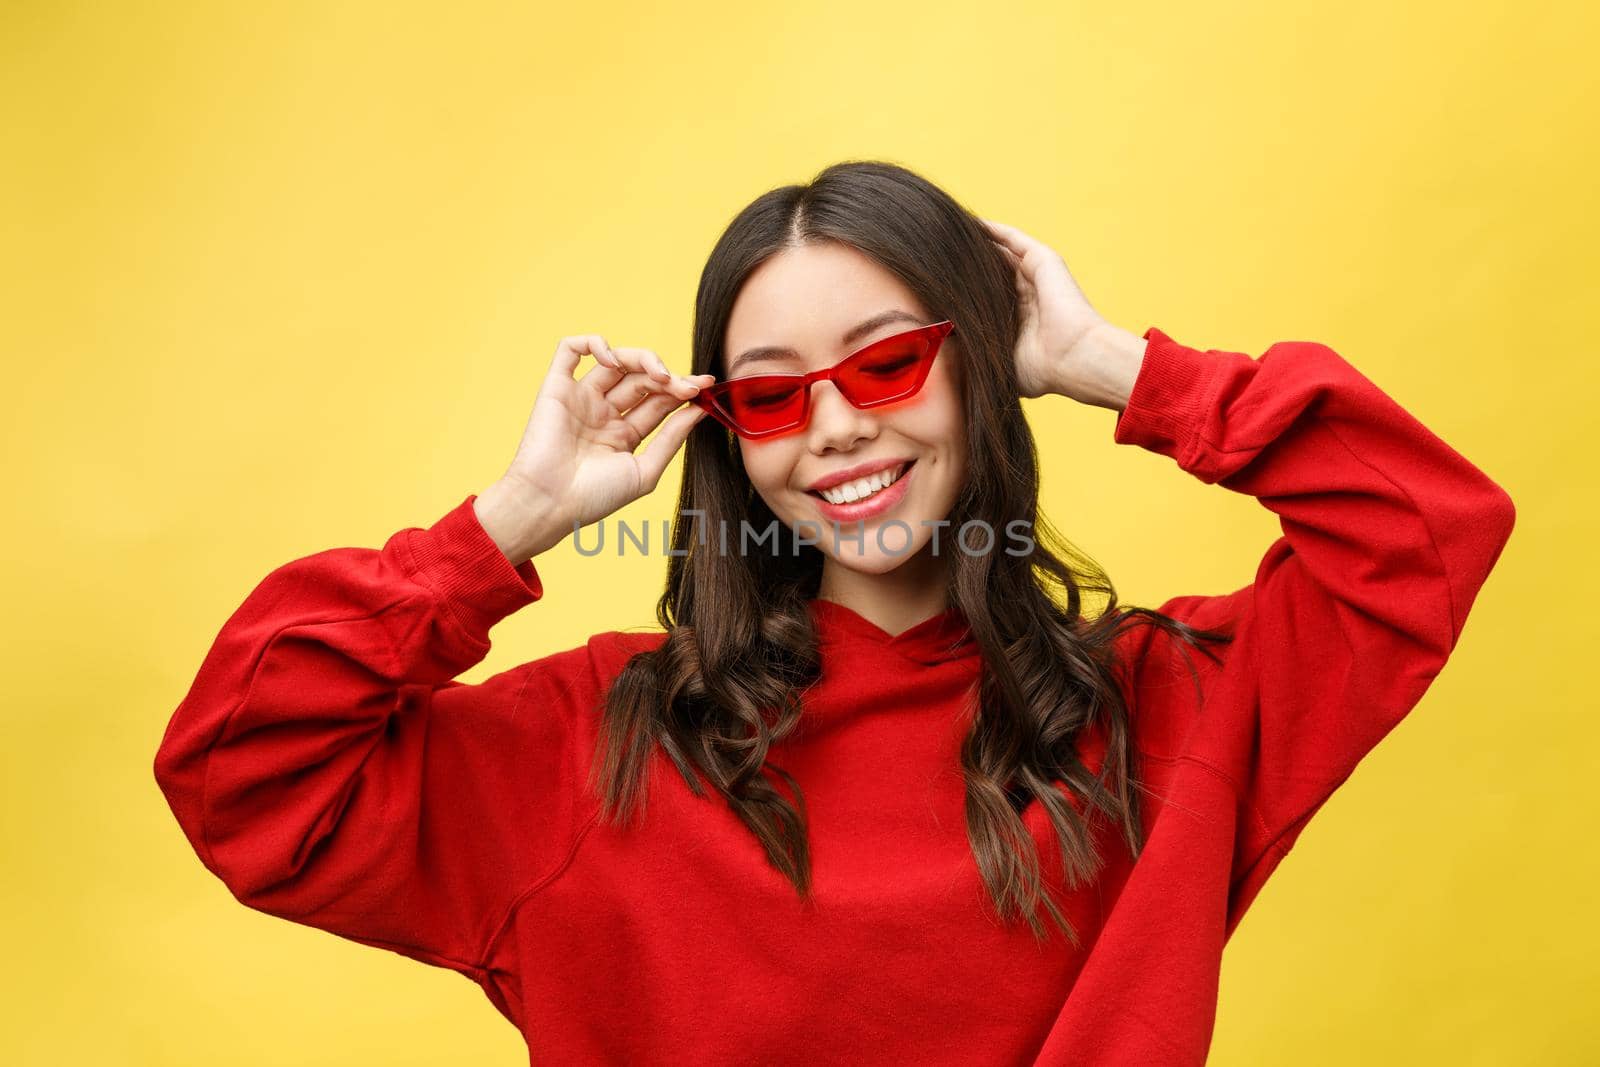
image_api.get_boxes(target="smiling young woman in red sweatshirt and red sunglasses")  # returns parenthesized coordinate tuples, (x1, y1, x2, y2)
(155, 162, 1515, 1064)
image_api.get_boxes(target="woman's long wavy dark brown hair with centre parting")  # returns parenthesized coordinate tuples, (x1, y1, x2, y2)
(590, 160, 1229, 944)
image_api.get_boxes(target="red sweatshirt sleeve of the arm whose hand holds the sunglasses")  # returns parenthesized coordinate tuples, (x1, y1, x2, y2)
(155, 496, 600, 995)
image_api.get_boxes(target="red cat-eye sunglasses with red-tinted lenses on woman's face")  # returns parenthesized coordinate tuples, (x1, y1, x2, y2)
(690, 320, 955, 440)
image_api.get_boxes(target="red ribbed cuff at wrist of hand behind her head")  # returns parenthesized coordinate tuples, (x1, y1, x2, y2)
(1112, 326, 1221, 466)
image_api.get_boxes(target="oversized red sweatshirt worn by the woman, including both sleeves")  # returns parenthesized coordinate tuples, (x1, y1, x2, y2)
(155, 328, 1515, 1065)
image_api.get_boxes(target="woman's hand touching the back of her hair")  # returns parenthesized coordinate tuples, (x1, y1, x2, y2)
(982, 219, 1106, 400)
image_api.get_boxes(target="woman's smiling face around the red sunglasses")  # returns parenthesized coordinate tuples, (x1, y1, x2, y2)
(718, 242, 966, 574)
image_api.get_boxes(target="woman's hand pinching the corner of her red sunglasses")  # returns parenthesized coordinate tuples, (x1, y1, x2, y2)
(475, 334, 715, 563)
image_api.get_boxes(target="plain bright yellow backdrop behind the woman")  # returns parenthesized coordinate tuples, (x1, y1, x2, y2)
(0, 0, 1600, 1065)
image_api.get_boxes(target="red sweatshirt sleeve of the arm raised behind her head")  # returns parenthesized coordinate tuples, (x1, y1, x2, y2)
(1114, 328, 1515, 933)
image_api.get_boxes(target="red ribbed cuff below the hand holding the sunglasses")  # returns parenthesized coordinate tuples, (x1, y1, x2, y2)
(406, 493, 544, 638)
